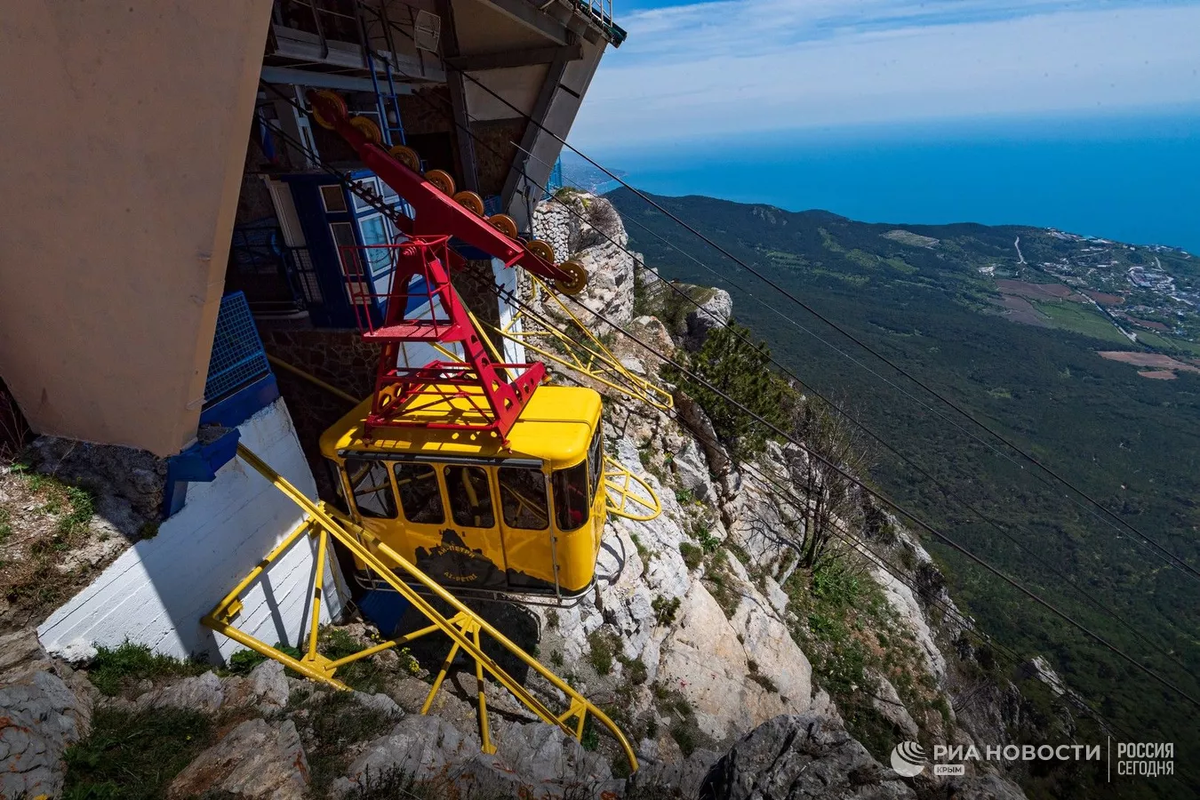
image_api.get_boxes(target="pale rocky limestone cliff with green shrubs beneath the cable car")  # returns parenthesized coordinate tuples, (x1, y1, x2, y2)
(0, 193, 1065, 800)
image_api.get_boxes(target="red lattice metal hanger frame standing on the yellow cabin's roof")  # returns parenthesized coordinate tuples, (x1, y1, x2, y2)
(341, 236, 546, 439)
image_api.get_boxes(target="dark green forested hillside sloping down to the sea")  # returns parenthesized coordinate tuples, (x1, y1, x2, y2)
(608, 190, 1200, 796)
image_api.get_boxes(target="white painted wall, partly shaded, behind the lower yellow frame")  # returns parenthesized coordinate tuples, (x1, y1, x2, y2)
(37, 398, 342, 660)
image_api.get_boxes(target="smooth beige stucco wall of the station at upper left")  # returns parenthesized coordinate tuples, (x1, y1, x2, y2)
(0, 0, 271, 455)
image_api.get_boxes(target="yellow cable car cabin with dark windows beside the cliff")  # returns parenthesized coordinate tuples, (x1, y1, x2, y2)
(320, 385, 606, 597)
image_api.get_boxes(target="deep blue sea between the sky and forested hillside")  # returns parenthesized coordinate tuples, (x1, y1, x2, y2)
(573, 108, 1200, 254)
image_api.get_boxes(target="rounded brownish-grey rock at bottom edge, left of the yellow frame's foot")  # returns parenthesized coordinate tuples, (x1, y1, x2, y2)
(167, 720, 308, 800)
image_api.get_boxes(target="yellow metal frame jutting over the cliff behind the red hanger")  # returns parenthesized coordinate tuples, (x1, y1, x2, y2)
(487, 275, 674, 411)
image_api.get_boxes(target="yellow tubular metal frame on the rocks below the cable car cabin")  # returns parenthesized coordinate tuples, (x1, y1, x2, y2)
(200, 444, 637, 770)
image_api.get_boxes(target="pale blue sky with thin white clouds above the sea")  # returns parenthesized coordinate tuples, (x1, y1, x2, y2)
(571, 0, 1200, 150)
